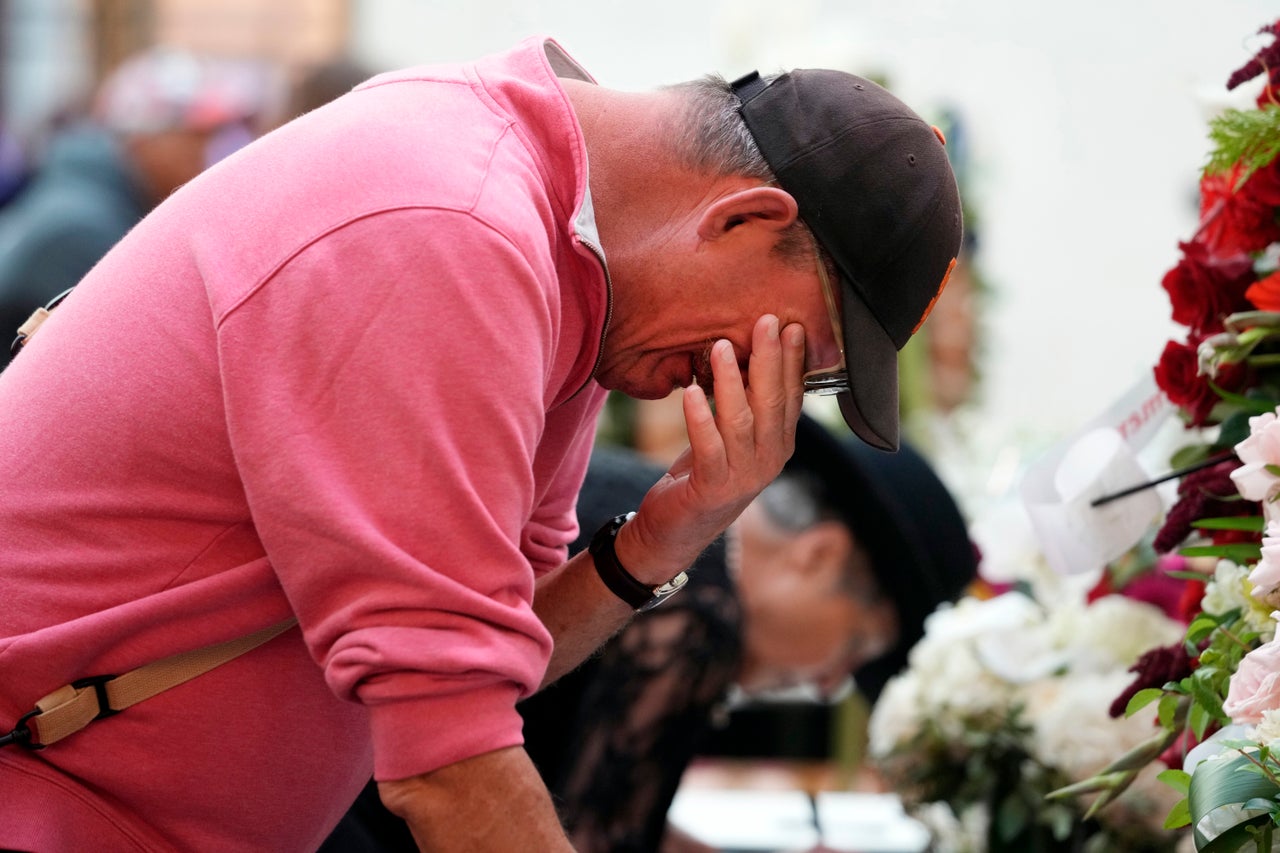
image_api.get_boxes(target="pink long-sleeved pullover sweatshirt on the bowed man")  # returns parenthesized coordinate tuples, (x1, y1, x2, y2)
(0, 40, 608, 853)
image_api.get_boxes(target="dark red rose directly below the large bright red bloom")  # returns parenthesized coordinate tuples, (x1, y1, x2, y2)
(1162, 242, 1253, 337)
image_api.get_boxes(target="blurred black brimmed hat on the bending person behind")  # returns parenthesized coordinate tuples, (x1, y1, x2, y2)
(786, 416, 978, 702)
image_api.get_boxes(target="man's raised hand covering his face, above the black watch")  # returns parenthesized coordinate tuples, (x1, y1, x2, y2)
(617, 315, 805, 583)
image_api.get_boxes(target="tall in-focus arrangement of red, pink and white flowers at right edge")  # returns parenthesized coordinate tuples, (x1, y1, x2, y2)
(1055, 16, 1280, 853)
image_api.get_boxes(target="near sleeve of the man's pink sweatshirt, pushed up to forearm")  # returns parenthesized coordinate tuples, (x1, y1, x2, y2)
(218, 210, 563, 779)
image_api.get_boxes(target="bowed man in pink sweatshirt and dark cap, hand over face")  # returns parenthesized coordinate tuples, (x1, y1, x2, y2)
(0, 38, 960, 852)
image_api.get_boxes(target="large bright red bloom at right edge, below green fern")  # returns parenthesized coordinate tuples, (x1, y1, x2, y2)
(1196, 161, 1280, 255)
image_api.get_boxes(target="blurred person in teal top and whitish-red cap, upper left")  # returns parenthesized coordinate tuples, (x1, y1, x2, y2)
(0, 47, 264, 366)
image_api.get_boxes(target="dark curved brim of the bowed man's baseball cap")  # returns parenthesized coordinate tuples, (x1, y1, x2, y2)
(836, 274, 899, 451)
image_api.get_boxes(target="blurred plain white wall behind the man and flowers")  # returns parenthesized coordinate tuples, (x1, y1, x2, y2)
(355, 0, 1280, 504)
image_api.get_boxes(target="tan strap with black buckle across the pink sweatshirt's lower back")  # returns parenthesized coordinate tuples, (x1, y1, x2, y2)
(12, 619, 298, 749)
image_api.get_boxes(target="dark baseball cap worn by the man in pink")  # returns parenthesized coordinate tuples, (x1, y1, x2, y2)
(732, 70, 961, 451)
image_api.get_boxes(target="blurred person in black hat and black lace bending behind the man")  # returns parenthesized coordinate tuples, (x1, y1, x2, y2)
(320, 416, 978, 853)
